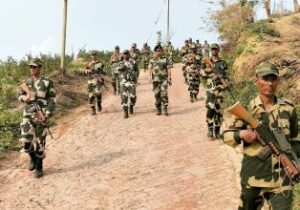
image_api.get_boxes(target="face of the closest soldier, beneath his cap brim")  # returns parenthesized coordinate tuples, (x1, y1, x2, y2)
(255, 74, 279, 96)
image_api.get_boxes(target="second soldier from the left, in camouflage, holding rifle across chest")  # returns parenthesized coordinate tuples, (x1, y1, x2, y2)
(86, 51, 105, 115)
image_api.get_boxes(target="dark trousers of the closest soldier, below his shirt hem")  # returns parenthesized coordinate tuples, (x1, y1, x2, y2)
(238, 185, 293, 210)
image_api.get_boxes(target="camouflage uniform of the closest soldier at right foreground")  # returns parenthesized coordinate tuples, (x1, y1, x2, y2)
(222, 96, 298, 210)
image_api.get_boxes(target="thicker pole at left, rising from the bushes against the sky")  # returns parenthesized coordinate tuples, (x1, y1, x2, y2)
(60, 0, 68, 76)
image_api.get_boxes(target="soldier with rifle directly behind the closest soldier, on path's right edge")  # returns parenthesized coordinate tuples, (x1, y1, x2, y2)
(203, 44, 227, 140)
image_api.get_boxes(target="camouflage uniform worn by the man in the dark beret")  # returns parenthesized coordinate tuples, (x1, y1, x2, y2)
(149, 57, 169, 114)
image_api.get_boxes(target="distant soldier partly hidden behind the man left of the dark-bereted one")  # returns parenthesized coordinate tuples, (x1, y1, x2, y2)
(110, 46, 122, 95)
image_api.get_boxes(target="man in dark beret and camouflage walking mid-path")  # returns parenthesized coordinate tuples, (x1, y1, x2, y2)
(149, 45, 172, 116)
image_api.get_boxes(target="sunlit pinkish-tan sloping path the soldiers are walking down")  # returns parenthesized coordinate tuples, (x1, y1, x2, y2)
(0, 66, 238, 210)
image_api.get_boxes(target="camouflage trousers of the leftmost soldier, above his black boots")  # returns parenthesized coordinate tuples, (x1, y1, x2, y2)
(20, 117, 47, 158)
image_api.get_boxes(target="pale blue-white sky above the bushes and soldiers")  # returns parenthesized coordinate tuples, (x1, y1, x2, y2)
(0, 0, 296, 59)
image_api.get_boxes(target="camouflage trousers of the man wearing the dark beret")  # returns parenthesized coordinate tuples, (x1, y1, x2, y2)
(153, 80, 169, 108)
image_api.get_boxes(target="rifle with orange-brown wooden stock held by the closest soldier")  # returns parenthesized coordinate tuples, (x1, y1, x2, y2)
(228, 102, 300, 183)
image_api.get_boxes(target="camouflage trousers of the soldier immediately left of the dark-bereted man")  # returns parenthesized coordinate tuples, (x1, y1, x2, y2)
(120, 82, 136, 108)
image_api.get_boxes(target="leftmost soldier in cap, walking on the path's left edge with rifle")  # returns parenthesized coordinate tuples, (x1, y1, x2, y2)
(19, 58, 56, 178)
